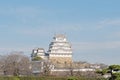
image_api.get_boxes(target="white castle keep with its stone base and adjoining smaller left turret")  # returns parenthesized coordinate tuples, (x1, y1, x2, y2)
(31, 34, 72, 64)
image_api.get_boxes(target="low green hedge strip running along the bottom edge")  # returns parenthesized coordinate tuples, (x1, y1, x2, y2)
(0, 76, 107, 80)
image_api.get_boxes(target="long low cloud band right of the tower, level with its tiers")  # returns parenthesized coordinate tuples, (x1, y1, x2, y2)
(73, 41, 120, 51)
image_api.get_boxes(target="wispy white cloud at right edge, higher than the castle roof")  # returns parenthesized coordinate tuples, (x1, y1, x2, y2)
(81, 18, 120, 31)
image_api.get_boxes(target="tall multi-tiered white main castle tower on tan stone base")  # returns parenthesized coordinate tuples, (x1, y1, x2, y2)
(48, 34, 72, 64)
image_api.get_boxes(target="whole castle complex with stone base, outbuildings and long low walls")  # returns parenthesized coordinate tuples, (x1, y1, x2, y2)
(31, 34, 100, 75)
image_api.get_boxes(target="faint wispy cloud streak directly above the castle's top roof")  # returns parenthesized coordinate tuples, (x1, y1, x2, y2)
(16, 23, 81, 36)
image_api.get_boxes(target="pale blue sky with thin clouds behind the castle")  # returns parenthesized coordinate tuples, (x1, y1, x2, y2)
(0, 0, 120, 64)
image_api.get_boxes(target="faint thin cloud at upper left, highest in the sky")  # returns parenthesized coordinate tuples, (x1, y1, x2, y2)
(0, 6, 41, 17)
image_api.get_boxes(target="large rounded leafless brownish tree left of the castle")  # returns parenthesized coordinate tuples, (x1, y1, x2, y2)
(1, 52, 30, 76)
